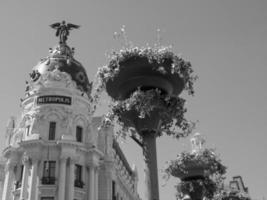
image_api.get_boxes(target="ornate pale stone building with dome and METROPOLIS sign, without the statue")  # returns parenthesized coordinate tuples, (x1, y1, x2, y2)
(0, 27, 139, 200)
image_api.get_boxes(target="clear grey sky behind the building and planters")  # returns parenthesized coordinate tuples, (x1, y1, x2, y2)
(0, 0, 267, 200)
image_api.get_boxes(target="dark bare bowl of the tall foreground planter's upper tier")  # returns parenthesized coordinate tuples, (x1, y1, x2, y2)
(106, 55, 184, 100)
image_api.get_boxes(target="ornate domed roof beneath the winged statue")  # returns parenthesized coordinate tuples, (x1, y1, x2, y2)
(30, 43, 92, 96)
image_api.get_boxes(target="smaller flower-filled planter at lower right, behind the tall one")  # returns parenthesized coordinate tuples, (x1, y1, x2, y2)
(165, 149, 226, 199)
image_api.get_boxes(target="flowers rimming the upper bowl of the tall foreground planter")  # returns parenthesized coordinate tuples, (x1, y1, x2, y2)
(95, 47, 197, 101)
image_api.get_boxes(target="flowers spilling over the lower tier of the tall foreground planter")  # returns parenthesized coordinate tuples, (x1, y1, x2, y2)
(101, 89, 194, 138)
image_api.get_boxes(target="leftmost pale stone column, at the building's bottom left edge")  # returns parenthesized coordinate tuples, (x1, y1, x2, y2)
(2, 159, 15, 200)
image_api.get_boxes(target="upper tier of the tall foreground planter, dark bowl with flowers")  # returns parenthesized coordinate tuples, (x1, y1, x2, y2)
(97, 47, 196, 100)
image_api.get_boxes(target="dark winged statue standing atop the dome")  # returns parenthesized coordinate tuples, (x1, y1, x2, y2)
(50, 21, 80, 44)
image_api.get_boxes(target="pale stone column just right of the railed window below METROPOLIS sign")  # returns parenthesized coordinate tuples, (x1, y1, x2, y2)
(58, 157, 67, 200)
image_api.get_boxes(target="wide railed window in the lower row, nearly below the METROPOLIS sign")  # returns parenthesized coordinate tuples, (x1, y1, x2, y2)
(42, 161, 56, 185)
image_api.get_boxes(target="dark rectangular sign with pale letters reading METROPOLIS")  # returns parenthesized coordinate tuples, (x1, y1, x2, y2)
(37, 95, 71, 105)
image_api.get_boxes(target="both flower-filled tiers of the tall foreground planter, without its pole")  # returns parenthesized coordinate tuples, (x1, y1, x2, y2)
(96, 47, 196, 138)
